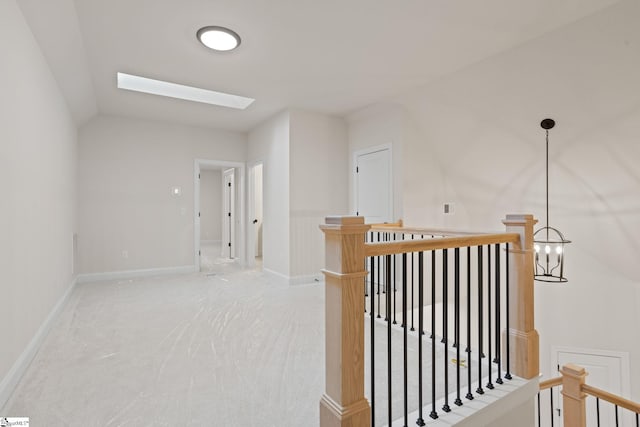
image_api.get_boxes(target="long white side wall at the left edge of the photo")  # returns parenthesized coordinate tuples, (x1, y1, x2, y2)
(0, 0, 77, 408)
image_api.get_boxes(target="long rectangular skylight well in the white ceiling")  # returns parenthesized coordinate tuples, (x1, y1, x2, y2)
(118, 73, 255, 110)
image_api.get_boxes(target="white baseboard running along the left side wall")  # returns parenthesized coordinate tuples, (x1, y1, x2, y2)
(0, 277, 78, 414)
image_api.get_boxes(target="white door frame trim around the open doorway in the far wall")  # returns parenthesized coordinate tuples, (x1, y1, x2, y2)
(193, 159, 246, 272)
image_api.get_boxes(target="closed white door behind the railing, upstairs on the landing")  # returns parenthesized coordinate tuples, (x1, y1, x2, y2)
(355, 148, 393, 223)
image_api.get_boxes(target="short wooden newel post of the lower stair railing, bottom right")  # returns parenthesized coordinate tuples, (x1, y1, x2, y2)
(560, 363, 587, 427)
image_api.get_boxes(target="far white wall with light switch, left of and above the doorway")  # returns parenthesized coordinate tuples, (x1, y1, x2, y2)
(79, 116, 246, 273)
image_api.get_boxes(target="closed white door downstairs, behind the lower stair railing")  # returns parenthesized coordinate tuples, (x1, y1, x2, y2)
(554, 350, 628, 427)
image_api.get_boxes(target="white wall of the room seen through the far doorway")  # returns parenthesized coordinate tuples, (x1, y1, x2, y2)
(200, 170, 223, 241)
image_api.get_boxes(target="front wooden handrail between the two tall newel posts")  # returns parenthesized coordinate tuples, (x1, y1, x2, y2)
(364, 233, 520, 257)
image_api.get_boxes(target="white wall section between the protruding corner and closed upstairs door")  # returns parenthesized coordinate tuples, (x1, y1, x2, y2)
(290, 110, 349, 281)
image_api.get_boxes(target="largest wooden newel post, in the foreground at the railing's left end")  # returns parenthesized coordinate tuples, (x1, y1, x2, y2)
(320, 217, 371, 427)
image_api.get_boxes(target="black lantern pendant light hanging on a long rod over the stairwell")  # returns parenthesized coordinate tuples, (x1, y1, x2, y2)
(533, 119, 571, 283)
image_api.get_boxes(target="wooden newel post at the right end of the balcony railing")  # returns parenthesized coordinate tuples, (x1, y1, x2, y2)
(502, 215, 540, 379)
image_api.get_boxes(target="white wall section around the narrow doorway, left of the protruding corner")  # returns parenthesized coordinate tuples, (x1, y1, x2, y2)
(247, 112, 290, 279)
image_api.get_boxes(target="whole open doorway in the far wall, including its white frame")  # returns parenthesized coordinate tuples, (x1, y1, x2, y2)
(194, 159, 246, 271)
